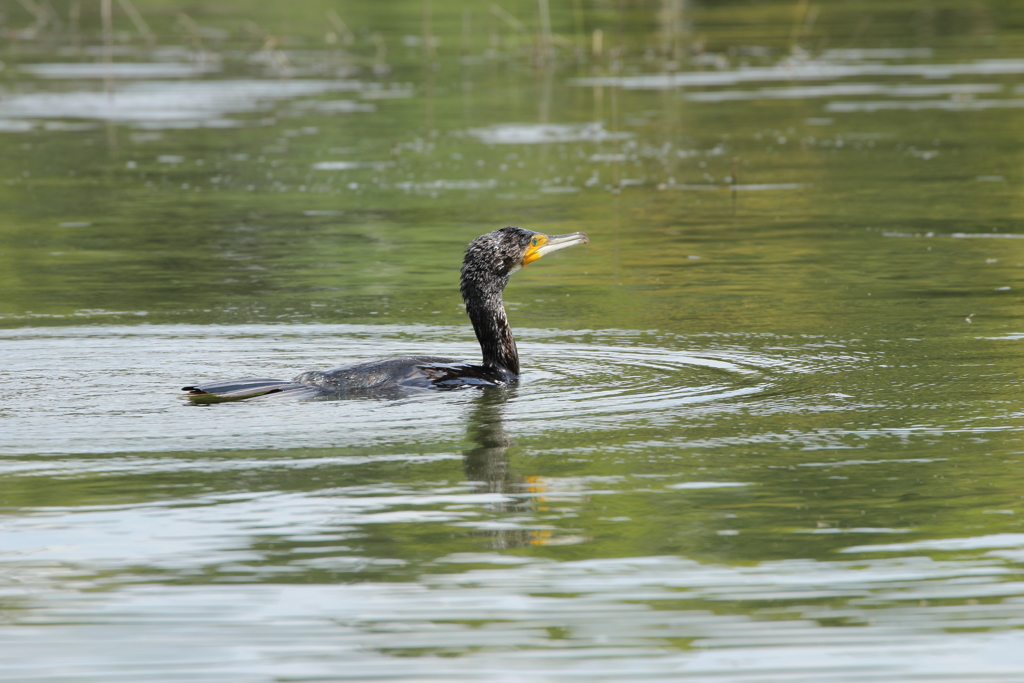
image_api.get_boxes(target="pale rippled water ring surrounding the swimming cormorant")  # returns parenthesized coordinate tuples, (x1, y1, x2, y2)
(0, 325, 839, 455)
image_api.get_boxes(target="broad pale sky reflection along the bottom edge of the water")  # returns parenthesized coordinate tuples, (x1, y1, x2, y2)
(0, 554, 1022, 681)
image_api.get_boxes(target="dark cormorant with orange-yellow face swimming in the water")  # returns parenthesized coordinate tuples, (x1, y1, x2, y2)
(182, 226, 590, 403)
